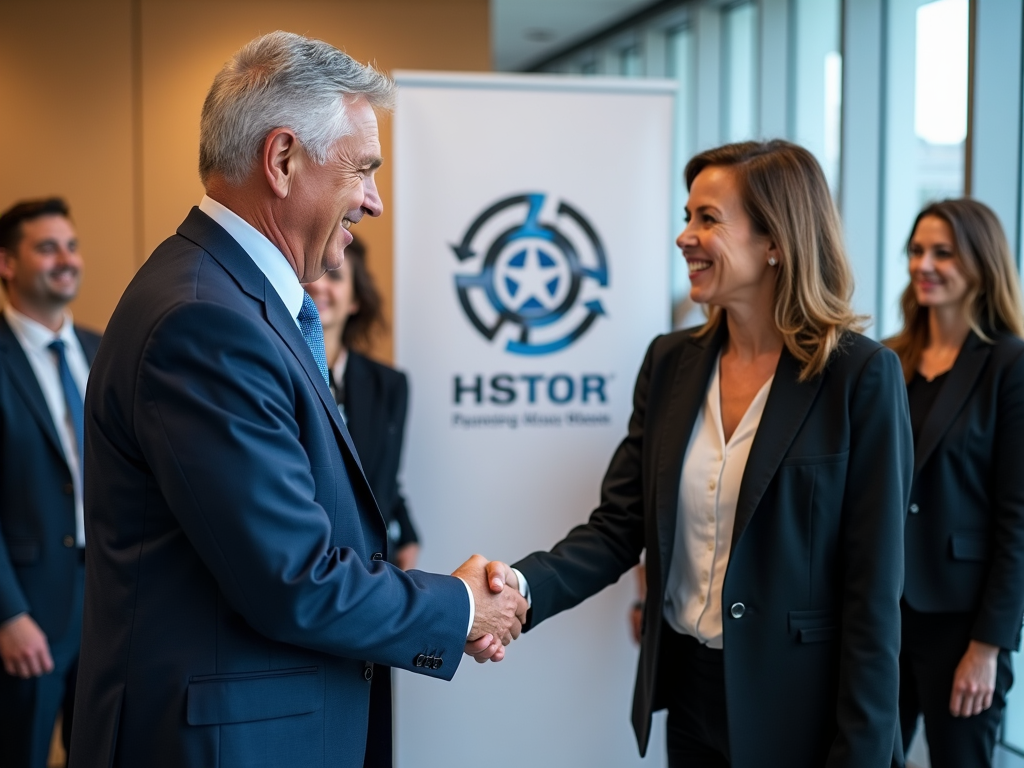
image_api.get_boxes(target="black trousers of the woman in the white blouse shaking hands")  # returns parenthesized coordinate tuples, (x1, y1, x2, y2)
(659, 625, 729, 768)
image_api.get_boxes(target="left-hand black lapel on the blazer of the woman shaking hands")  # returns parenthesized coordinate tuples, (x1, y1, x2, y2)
(654, 321, 727, 584)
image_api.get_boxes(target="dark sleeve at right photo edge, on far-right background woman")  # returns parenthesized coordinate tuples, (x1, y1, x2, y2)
(971, 346, 1024, 650)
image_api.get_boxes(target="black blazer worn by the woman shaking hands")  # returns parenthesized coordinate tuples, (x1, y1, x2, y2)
(516, 324, 913, 768)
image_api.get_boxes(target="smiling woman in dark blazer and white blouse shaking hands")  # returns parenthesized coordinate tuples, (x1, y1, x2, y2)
(492, 141, 912, 768)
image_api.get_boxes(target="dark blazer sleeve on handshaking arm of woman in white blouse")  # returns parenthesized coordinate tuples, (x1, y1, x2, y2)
(513, 339, 657, 630)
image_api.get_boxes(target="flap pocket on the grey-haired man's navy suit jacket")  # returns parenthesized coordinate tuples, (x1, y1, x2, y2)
(187, 667, 324, 725)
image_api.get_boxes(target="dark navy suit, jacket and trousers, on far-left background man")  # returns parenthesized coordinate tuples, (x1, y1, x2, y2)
(0, 313, 99, 766)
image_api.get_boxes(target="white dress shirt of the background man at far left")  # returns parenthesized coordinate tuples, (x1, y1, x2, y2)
(3, 303, 89, 547)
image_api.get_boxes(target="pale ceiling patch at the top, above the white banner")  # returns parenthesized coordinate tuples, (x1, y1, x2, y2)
(490, 0, 651, 72)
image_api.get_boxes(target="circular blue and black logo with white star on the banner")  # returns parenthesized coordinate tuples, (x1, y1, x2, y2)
(452, 193, 608, 354)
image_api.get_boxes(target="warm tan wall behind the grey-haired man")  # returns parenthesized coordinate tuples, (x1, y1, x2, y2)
(0, 0, 490, 359)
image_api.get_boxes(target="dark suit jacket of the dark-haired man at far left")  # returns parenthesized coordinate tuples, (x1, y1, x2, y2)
(0, 314, 99, 642)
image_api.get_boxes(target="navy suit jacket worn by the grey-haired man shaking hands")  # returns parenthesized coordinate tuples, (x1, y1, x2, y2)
(71, 209, 469, 768)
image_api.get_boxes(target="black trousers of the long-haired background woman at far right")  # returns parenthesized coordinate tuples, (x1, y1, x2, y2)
(899, 603, 1014, 768)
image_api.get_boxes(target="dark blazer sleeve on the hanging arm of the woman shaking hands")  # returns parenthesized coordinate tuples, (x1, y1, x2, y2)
(826, 349, 913, 768)
